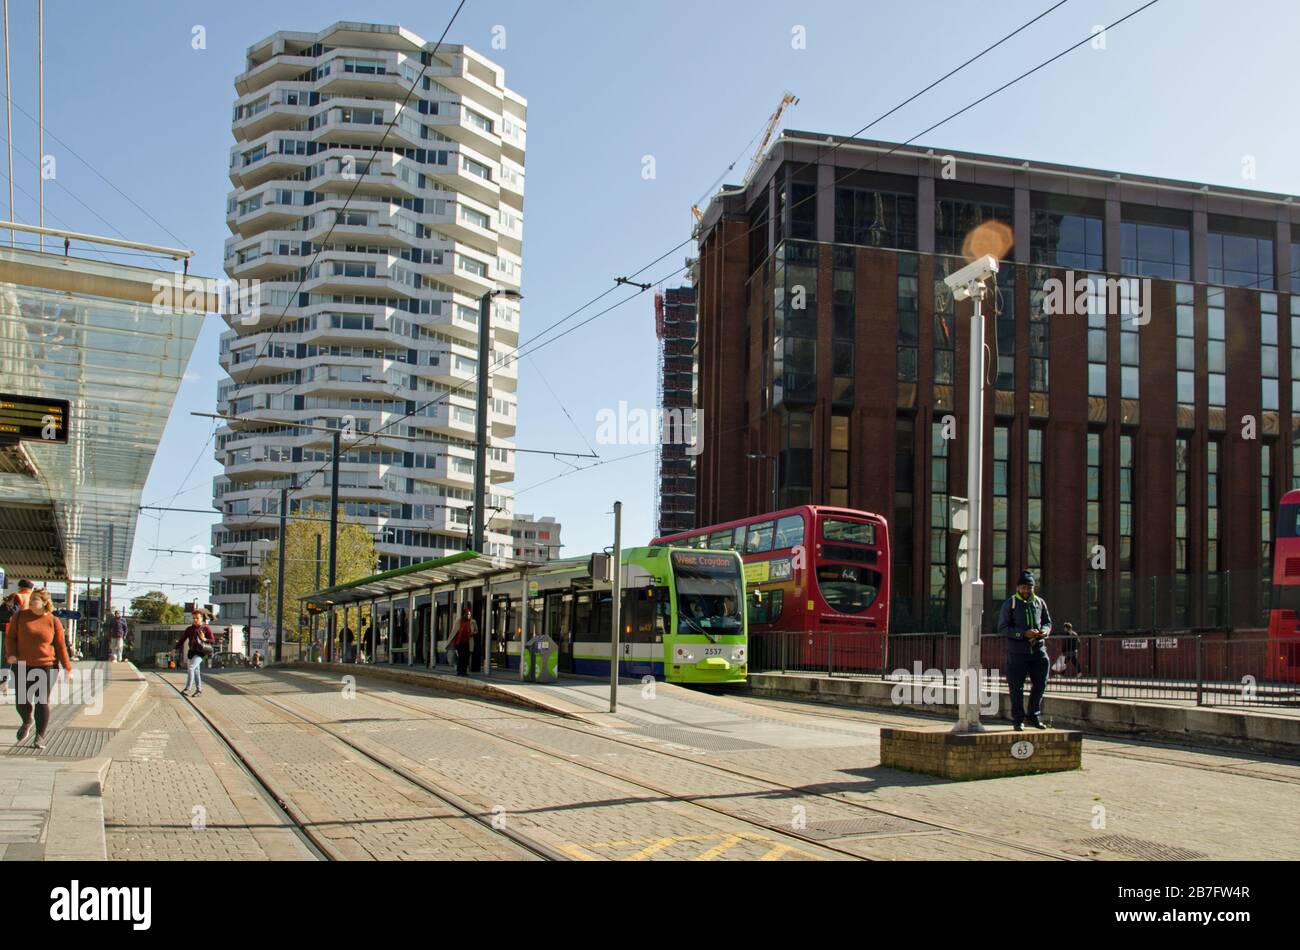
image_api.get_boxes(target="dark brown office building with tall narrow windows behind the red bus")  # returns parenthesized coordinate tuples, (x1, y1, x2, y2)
(696, 133, 1300, 632)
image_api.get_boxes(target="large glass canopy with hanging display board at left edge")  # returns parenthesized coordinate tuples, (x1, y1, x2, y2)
(0, 237, 218, 581)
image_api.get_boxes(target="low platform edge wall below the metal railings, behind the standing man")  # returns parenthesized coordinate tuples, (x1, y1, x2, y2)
(749, 673, 1300, 759)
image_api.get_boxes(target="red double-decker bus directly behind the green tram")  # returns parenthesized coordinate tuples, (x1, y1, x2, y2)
(654, 504, 889, 669)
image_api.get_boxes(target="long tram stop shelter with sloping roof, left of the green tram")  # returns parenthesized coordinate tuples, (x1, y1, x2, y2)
(299, 551, 541, 672)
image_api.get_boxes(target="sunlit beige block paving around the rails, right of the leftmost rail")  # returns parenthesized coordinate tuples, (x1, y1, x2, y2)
(119, 671, 1300, 860)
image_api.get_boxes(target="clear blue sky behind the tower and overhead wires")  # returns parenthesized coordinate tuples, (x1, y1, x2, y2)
(0, 0, 1300, 599)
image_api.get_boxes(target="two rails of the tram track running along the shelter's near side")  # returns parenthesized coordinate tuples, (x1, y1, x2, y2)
(258, 671, 1088, 860)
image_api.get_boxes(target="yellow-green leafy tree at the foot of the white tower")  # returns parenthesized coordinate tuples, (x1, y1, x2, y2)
(257, 516, 380, 643)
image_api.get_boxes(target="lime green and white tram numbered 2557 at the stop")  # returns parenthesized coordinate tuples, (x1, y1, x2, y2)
(502, 547, 749, 684)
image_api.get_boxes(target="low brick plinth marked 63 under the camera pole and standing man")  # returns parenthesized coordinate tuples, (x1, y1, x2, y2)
(880, 726, 1083, 778)
